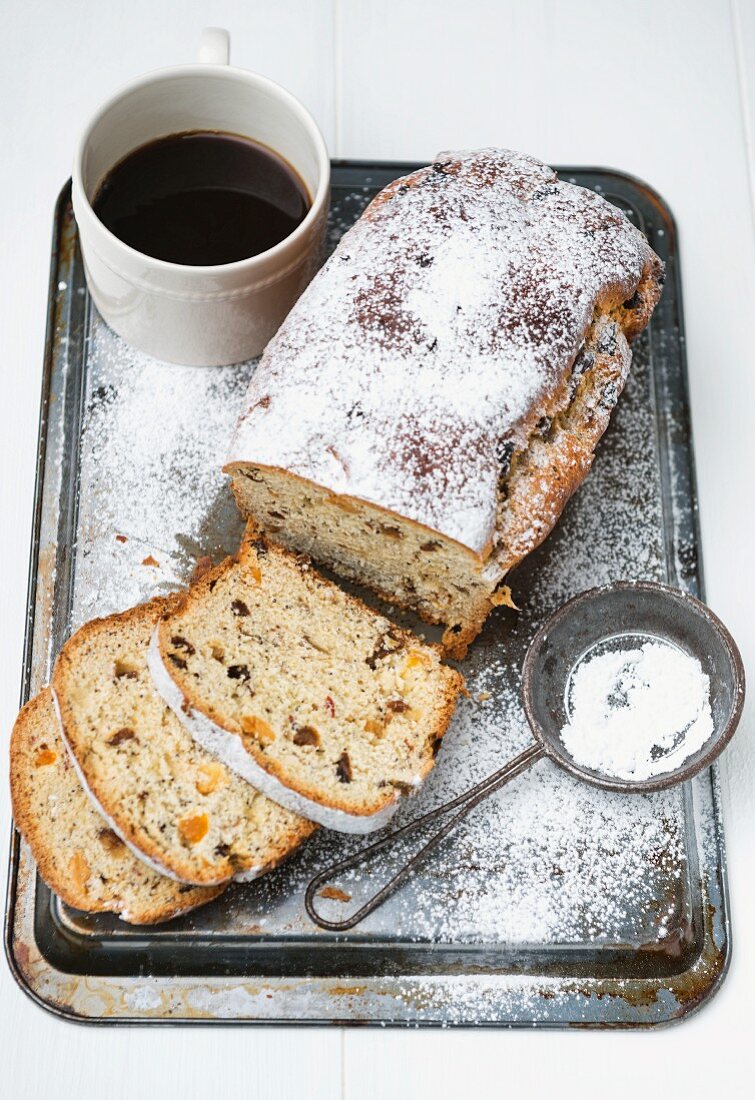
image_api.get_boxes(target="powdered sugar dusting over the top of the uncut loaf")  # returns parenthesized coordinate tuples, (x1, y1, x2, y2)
(229, 150, 650, 552)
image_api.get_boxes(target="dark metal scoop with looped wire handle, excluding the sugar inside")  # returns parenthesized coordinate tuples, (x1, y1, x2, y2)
(305, 582, 745, 932)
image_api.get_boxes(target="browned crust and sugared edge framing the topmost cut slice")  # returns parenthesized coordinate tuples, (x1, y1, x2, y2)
(147, 526, 463, 833)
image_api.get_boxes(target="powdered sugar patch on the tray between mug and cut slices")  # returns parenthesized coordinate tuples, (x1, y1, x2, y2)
(73, 316, 249, 626)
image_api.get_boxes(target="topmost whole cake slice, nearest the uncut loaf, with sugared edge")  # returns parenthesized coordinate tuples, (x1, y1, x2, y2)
(150, 529, 463, 833)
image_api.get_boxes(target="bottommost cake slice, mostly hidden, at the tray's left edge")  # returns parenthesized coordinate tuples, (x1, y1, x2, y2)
(11, 688, 225, 924)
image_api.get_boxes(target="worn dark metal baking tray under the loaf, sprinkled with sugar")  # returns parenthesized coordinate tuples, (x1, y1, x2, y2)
(6, 162, 731, 1027)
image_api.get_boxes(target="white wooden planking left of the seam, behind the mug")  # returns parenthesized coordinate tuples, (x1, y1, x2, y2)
(0, 0, 341, 1100)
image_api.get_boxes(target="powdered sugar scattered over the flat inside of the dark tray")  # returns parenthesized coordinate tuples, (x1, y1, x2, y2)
(73, 178, 690, 958)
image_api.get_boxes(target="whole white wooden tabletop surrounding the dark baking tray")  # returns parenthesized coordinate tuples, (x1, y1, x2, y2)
(0, 0, 755, 1100)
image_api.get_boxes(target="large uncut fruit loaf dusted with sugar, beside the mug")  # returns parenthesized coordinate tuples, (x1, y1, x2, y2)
(226, 150, 663, 657)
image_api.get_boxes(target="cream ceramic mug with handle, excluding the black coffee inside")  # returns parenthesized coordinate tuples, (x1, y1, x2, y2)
(73, 29, 330, 366)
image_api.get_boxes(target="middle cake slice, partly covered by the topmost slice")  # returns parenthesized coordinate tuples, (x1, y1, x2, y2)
(52, 597, 315, 886)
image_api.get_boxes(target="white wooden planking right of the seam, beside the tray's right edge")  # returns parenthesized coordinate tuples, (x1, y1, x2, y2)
(339, 0, 755, 1100)
